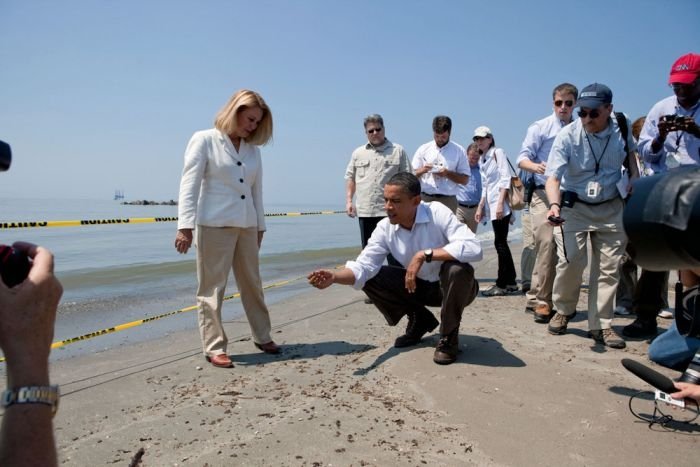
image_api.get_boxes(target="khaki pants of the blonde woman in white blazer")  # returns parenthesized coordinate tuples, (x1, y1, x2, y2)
(196, 225, 272, 356)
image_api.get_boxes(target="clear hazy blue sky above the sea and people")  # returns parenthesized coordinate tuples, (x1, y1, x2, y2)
(0, 0, 700, 209)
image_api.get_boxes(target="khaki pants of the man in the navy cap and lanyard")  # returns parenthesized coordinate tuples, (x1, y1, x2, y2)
(552, 198, 627, 331)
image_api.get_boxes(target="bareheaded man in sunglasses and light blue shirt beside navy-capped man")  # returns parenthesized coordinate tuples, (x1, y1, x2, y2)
(518, 83, 578, 323)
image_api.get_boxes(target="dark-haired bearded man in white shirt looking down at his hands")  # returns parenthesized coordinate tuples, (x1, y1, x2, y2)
(411, 115, 470, 213)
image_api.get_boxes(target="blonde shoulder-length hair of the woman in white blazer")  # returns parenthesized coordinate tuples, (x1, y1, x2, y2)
(214, 89, 272, 145)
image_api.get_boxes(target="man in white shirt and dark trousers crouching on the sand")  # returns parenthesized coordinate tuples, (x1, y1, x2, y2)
(308, 172, 482, 365)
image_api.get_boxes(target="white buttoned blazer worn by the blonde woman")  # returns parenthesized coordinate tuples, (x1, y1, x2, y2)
(177, 128, 265, 231)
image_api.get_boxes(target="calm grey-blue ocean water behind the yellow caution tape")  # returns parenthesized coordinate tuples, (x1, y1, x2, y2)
(0, 199, 520, 358)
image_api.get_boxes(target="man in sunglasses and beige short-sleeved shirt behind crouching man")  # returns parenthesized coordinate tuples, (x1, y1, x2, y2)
(345, 114, 411, 278)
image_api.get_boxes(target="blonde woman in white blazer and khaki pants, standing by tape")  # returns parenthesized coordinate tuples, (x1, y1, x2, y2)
(175, 89, 280, 368)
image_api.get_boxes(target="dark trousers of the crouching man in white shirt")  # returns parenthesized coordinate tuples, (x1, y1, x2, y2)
(362, 261, 479, 336)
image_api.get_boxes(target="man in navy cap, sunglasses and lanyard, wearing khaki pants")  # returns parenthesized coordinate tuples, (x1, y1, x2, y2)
(545, 83, 639, 349)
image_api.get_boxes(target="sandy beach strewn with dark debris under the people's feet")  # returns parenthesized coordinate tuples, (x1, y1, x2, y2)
(26, 246, 700, 466)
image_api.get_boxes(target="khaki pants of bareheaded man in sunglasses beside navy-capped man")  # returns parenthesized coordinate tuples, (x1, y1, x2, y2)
(527, 188, 556, 309)
